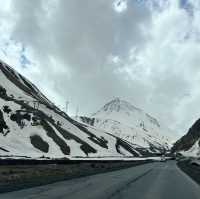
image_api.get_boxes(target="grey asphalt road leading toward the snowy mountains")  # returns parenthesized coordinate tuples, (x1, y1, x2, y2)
(0, 161, 200, 199)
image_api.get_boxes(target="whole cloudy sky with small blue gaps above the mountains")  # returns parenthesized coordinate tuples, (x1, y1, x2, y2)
(0, 0, 200, 135)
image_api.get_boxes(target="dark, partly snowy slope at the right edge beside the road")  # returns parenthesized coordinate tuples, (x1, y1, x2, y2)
(172, 119, 200, 157)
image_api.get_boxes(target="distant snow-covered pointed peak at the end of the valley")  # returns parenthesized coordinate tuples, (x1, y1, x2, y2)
(76, 98, 171, 153)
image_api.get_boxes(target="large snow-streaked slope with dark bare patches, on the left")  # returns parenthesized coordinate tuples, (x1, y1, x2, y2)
(0, 61, 164, 159)
